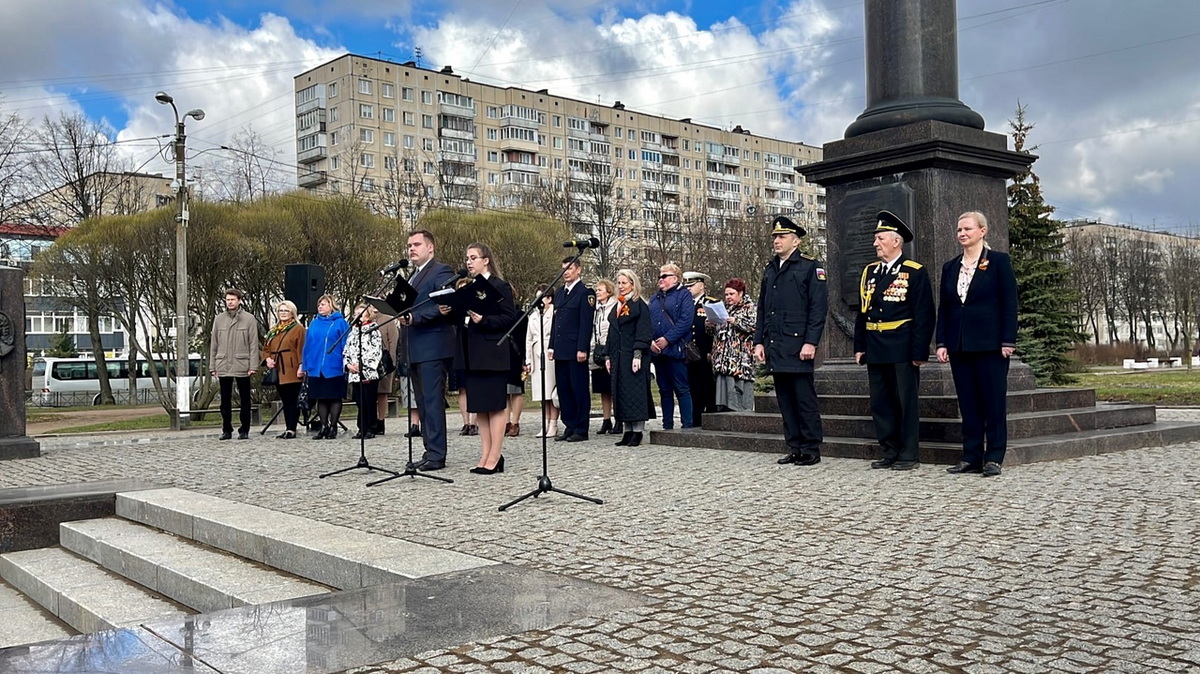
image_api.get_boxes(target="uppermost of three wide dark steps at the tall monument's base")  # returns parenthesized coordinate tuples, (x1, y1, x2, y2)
(755, 389, 1096, 419)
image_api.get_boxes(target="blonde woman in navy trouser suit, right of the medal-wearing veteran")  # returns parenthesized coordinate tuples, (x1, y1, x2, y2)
(936, 211, 1016, 477)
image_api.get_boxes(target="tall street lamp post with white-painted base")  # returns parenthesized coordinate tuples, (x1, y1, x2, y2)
(154, 91, 204, 431)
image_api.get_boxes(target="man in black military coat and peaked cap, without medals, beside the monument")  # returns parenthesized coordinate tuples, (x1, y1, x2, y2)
(754, 216, 829, 465)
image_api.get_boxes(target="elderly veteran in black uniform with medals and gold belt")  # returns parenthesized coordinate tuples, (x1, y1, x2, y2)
(854, 211, 935, 470)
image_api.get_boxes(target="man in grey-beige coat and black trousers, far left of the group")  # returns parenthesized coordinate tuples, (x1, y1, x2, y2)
(209, 288, 260, 440)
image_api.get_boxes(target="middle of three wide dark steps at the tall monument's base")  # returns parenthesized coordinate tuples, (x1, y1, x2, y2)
(703, 403, 1156, 443)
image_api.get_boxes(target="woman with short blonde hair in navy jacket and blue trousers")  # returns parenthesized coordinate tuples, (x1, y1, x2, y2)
(649, 264, 696, 431)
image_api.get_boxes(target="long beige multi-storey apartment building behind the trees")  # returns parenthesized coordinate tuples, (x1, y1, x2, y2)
(295, 54, 826, 251)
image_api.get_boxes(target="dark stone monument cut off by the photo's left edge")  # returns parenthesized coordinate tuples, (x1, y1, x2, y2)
(0, 265, 42, 459)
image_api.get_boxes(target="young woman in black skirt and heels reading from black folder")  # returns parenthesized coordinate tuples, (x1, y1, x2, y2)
(440, 243, 517, 475)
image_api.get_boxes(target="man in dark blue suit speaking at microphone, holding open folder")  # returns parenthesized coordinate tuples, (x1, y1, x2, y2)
(400, 229, 458, 470)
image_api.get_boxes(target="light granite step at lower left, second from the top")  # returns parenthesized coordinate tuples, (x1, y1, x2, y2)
(59, 517, 330, 613)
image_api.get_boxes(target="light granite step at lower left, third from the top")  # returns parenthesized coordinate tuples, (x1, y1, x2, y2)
(0, 547, 190, 633)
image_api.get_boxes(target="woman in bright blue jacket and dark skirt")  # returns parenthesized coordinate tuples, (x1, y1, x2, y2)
(300, 295, 350, 440)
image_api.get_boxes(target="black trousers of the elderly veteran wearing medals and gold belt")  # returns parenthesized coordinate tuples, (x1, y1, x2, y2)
(866, 362, 920, 461)
